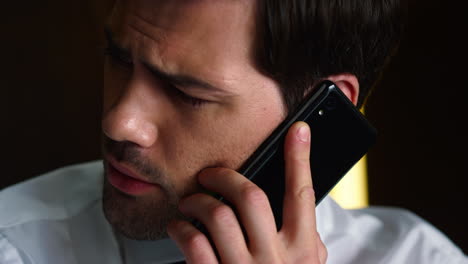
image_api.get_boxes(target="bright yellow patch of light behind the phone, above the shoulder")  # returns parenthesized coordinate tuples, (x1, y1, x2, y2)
(330, 108, 369, 209)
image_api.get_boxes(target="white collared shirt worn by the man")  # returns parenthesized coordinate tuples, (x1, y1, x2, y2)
(0, 161, 468, 264)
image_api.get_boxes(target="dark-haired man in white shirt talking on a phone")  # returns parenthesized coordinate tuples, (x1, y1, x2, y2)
(0, 0, 466, 263)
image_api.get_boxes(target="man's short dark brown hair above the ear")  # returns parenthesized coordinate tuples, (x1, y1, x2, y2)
(256, 0, 406, 111)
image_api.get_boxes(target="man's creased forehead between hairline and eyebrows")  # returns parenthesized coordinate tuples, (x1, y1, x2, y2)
(108, 0, 255, 88)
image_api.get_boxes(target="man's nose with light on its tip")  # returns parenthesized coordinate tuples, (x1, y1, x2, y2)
(102, 71, 158, 148)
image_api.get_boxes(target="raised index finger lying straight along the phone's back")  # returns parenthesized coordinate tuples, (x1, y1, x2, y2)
(281, 122, 316, 244)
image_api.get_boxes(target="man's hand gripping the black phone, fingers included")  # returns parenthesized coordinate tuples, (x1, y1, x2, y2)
(168, 122, 327, 264)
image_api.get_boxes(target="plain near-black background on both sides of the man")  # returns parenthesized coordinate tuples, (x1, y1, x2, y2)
(0, 0, 468, 253)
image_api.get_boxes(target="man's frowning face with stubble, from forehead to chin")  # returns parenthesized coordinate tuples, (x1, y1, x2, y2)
(102, 0, 286, 239)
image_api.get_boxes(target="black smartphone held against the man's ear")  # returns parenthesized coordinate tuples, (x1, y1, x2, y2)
(195, 81, 377, 234)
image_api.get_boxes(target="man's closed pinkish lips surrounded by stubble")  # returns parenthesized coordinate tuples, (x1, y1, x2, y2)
(105, 157, 160, 196)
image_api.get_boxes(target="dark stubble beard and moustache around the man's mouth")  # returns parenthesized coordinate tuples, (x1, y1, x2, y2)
(102, 139, 189, 240)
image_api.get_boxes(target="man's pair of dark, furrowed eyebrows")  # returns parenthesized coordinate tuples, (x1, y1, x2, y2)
(104, 26, 230, 94)
